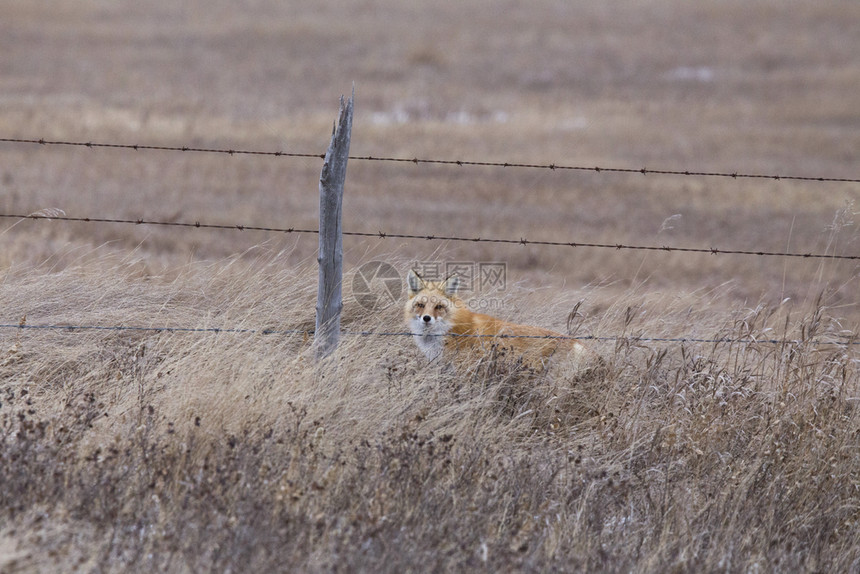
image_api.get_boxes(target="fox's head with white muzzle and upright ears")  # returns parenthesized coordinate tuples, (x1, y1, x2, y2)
(405, 271, 460, 358)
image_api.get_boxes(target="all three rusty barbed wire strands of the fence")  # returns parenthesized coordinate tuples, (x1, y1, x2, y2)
(0, 133, 860, 347)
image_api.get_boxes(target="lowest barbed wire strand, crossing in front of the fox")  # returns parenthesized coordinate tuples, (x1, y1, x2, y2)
(0, 323, 860, 346)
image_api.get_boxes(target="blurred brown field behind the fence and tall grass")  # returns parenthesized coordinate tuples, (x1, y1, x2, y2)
(0, 1, 860, 310)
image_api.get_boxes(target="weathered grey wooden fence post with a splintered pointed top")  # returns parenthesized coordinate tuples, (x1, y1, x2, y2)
(314, 90, 355, 359)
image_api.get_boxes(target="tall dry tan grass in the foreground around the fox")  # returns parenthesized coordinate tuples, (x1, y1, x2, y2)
(0, 253, 860, 572)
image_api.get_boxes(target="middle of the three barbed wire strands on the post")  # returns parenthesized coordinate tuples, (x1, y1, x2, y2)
(0, 213, 860, 260)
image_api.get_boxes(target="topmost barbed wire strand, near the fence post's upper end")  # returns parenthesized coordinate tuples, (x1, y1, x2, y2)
(0, 138, 860, 183)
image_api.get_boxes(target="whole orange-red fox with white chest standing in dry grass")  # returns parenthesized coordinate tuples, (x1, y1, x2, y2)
(406, 271, 590, 367)
